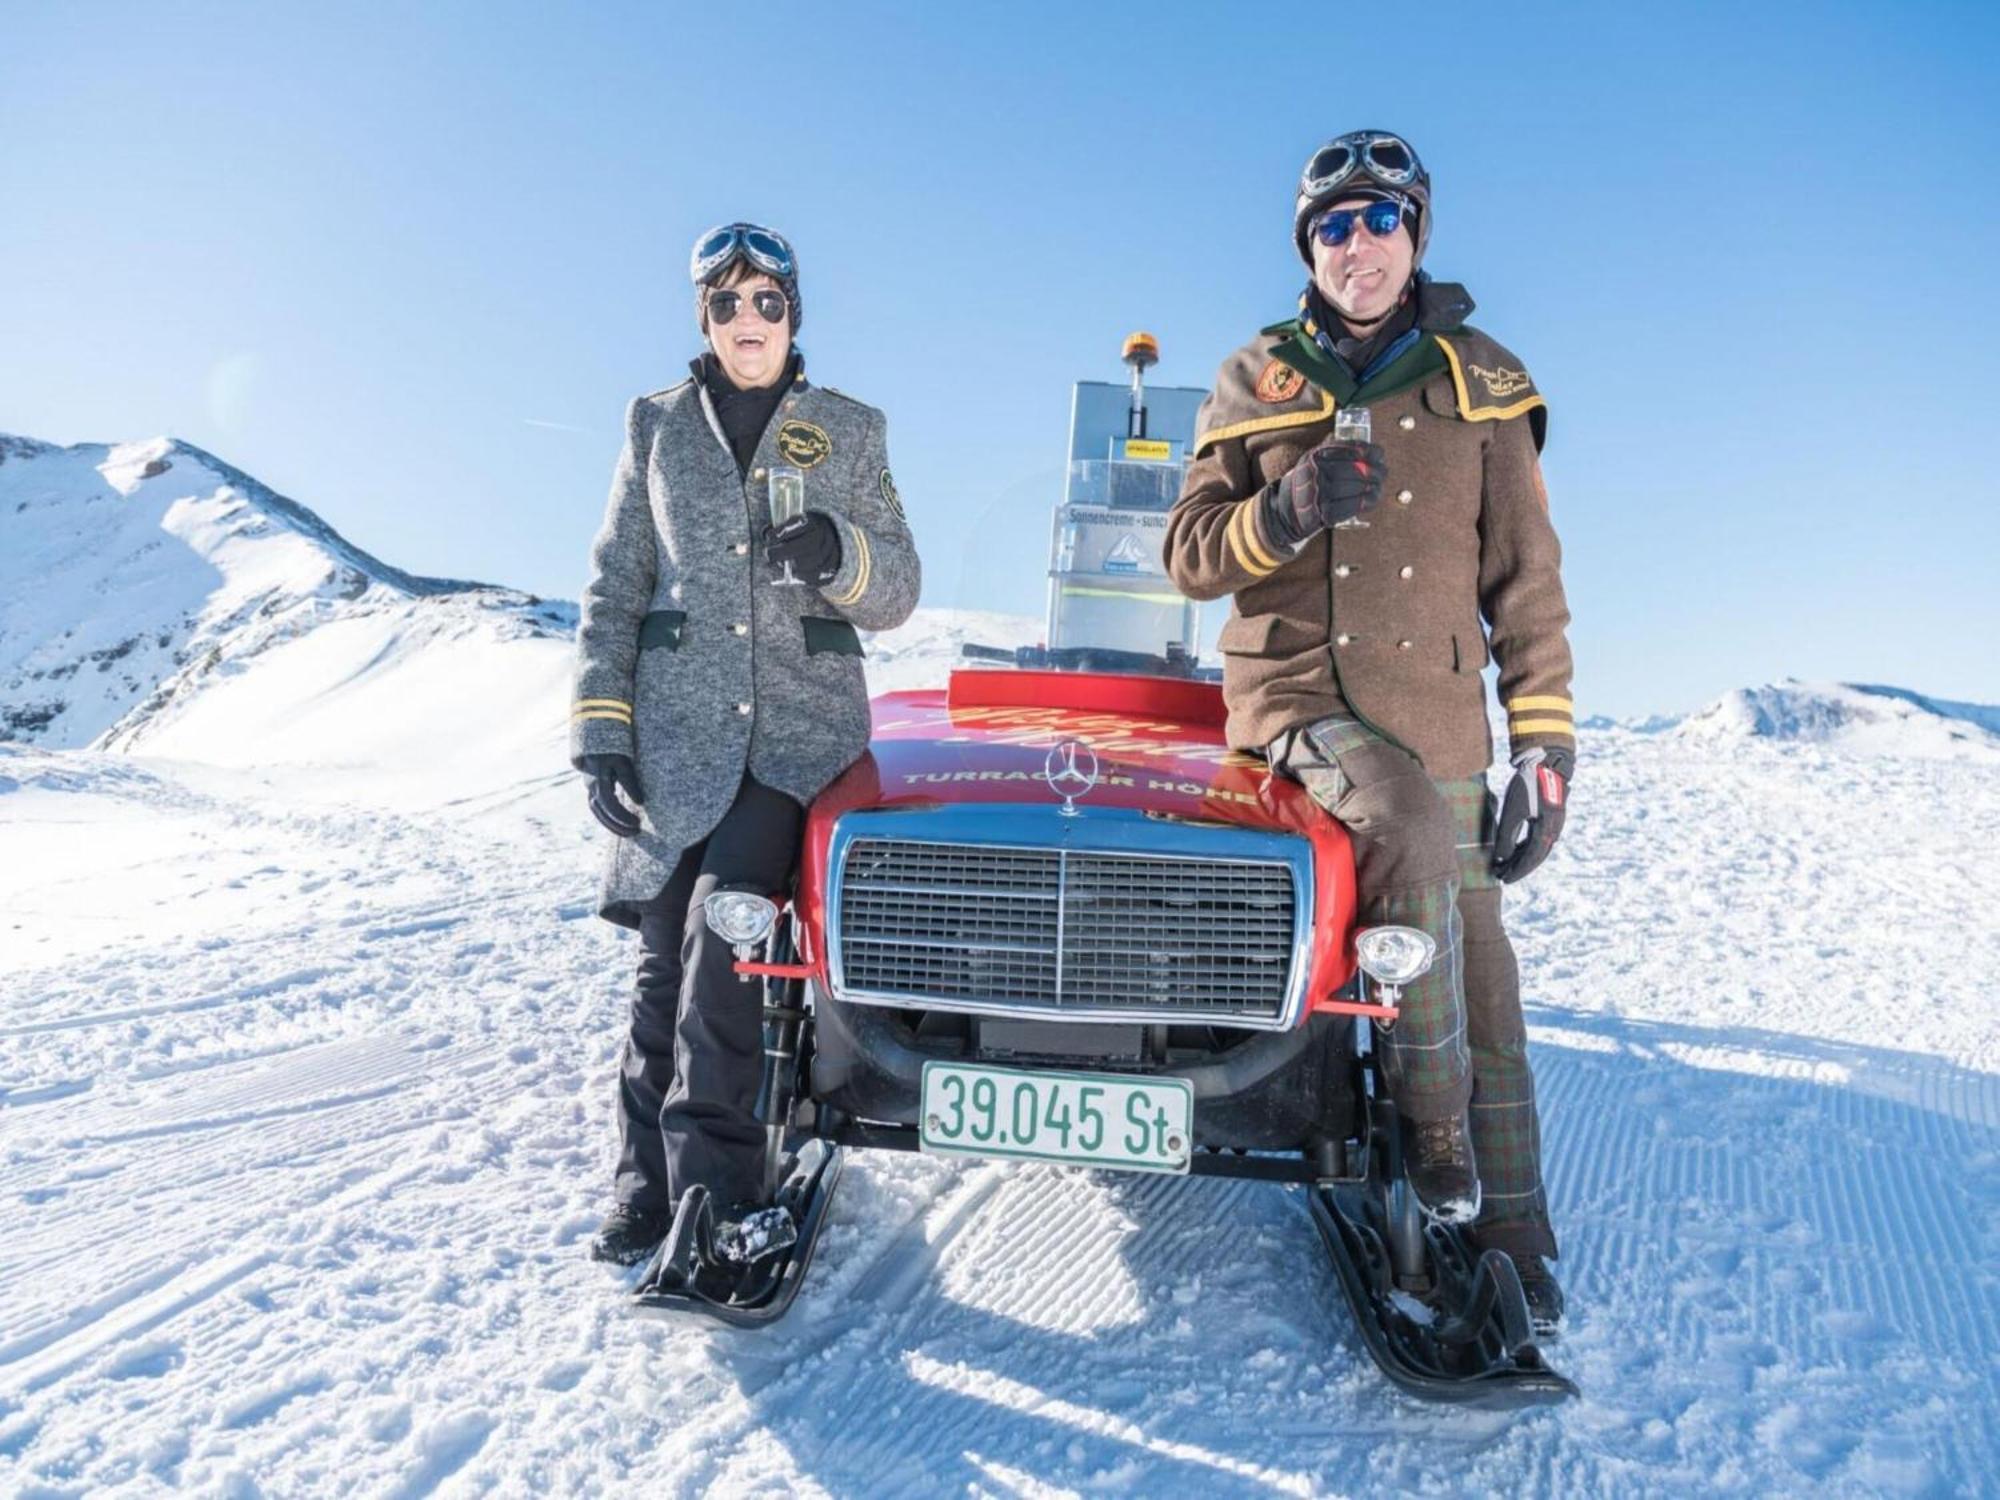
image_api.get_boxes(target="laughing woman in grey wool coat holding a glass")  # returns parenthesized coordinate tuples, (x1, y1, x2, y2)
(570, 224, 920, 1264)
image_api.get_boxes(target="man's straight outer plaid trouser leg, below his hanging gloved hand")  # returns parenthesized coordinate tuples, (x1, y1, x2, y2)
(1438, 776, 1556, 1258)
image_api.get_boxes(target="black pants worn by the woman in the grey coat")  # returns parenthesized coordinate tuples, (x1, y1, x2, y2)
(616, 776, 806, 1208)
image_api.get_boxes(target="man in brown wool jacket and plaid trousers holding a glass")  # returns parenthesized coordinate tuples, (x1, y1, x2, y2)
(1166, 130, 1576, 1328)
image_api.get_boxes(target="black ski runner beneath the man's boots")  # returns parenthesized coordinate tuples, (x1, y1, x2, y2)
(1306, 1184, 1576, 1410)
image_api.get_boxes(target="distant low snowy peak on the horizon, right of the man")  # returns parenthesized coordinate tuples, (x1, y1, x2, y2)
(1674, 678, 2000, 764)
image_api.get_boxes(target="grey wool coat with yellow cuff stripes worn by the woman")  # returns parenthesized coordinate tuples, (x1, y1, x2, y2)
(570, 376, 922, 926)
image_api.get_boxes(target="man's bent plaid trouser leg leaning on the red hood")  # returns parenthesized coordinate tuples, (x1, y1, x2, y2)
(1270, 714, 1480, 1128)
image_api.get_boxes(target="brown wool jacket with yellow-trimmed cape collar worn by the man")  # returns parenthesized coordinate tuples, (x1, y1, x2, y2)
(1166, 282, 1576, 778)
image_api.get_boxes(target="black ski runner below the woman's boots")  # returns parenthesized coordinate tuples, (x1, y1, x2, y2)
(632, 1140, 842, 1328)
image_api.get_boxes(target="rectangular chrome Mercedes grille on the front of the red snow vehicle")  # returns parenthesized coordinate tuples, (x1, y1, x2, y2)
(834, 838, 1296, 1022)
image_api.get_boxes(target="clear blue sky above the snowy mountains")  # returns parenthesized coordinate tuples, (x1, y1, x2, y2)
(0, 4, 2000, 714)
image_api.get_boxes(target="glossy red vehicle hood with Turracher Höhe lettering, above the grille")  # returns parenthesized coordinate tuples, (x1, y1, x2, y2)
(800, 670, 1354, 1016)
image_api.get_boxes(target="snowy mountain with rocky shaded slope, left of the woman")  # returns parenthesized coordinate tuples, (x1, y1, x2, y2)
(0, 434, 576, 754)
